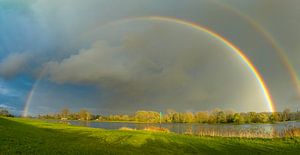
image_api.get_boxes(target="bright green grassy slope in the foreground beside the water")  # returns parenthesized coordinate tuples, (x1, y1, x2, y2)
(0, 118, 300, 154)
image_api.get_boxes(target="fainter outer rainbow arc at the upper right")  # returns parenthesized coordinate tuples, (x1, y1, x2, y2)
(211, 0, 300, 96)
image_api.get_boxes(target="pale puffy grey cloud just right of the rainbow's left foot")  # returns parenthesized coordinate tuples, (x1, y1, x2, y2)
(45, 42, 130, 83)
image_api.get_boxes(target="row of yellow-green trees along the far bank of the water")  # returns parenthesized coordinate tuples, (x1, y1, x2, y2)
(39, 108, 300, 124)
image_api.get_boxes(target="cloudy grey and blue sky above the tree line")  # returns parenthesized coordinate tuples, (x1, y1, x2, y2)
(0, 0, 300, 115)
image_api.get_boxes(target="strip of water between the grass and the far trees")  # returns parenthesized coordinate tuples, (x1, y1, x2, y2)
(47, 121, 300, 134)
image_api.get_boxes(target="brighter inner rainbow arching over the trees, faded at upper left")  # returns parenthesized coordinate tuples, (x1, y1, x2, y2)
(23, 16, 275, 117)
